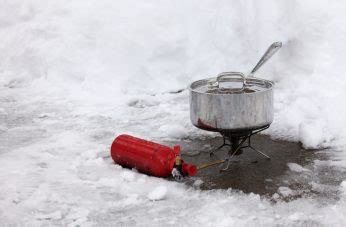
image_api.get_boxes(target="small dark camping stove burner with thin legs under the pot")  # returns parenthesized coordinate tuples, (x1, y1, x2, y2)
(210, 125, 270, 171)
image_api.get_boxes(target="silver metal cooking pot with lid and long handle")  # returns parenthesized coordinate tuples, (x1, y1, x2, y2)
(189, 42, 281, 132)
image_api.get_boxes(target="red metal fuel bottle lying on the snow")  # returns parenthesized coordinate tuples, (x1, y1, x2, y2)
(111, 135, 197, 177)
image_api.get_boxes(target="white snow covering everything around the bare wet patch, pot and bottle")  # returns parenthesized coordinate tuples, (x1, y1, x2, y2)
(0, 0, 346, 226)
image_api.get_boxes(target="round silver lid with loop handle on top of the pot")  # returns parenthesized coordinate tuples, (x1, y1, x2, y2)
(190, 72, 273, 94)
